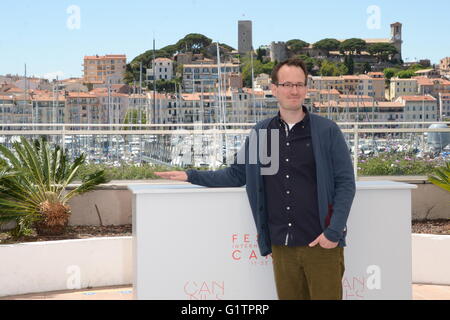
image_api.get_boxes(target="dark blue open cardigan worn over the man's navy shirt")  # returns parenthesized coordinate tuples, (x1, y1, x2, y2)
(187, 113, 356, 256)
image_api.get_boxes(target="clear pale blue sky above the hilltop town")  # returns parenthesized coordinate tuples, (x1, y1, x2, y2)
(0, 0, 450, 79)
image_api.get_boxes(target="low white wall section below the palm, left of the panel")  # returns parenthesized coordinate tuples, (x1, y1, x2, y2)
(0, 237, 132, 296)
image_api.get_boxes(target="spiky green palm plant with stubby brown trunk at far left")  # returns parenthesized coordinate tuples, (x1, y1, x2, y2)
(0, 137, 107, 237)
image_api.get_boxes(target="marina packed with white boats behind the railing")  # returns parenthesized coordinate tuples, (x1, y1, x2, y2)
(0, 122, 450, 169)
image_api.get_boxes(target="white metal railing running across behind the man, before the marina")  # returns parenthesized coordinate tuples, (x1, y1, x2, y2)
(0, 121, 450, 176)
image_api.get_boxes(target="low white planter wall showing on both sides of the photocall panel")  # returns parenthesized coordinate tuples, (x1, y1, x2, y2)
(0, 234, 450, 296)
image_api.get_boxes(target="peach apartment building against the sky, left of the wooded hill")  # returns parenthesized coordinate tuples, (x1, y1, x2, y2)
(83, 54, 127, 84)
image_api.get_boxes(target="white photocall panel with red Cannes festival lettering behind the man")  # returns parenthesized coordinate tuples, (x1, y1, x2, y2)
(129, 181, 415, 300)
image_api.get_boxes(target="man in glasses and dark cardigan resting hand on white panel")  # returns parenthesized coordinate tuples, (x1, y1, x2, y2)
(157, 59, 355, 299)
